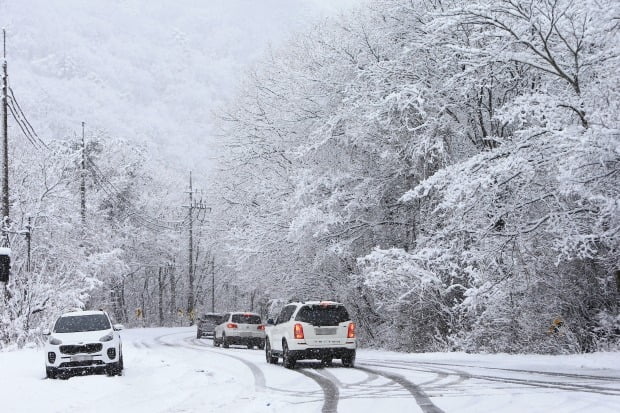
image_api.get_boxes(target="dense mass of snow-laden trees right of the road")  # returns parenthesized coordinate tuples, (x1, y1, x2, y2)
(212, 0, 619, 352)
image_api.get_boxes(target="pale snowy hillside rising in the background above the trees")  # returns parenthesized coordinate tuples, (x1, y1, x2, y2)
(0, 0, 355, 169)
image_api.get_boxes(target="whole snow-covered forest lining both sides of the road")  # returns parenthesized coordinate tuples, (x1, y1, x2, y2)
(0, 0, 620, 354)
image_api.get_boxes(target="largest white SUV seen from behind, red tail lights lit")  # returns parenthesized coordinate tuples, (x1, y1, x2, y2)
(265, 301, 357, 368)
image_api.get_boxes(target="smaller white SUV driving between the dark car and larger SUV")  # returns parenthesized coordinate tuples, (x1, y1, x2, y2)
(213, 312, 265, 349)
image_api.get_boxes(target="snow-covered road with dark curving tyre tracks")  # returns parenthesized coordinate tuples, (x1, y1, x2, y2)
(0, 328, 620, 413)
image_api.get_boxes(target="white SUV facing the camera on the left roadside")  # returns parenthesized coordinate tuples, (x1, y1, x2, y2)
(43, 311, 123, 379)
